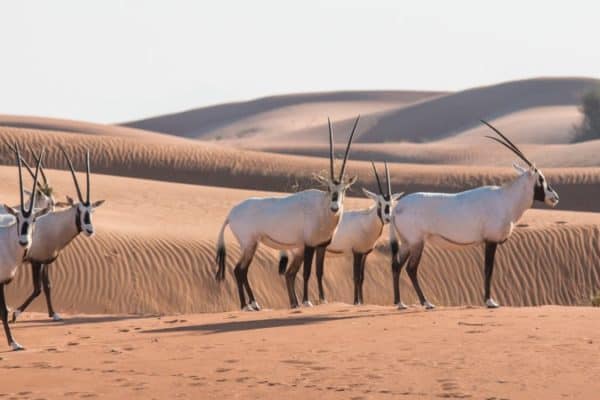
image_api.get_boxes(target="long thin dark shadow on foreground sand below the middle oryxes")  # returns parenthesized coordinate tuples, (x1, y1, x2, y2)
(143, 314, 390, 334)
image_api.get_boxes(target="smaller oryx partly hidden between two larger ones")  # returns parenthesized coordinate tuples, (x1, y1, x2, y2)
(279, 162, 404, 305)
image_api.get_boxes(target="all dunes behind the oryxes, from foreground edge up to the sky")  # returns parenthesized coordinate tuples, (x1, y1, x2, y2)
(0, 78, 600, 314)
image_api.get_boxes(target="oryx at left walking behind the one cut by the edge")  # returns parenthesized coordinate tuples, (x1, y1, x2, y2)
(12, 147, 104, 322)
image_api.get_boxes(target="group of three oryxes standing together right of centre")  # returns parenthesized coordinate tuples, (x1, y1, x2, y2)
(216, 118, 558, 311)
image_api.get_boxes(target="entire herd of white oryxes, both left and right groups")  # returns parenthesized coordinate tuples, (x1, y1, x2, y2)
(0, 117, 558, 350)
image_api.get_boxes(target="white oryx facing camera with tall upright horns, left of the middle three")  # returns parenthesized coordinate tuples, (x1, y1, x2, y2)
(216, 116, 360, 310)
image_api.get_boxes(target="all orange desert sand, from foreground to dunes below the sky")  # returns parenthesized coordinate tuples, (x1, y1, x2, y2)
(0, 78, 600, 399)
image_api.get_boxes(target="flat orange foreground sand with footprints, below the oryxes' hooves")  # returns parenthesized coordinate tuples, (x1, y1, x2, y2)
(0, 304, 600, 400)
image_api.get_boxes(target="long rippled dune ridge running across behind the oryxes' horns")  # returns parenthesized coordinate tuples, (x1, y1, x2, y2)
(0, 127, 600, 211)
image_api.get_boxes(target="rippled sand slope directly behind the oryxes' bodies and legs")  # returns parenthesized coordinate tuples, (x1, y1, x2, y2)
(0, 167, 600, 313)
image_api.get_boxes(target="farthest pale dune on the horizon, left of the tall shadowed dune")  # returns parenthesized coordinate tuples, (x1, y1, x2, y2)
(123, 91, 442, 139)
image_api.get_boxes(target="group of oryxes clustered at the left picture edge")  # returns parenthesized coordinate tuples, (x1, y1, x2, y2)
(0, 144, 104, 350)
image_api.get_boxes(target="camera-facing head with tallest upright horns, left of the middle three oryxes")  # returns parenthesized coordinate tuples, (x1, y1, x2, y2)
(317, 115, 360, 213)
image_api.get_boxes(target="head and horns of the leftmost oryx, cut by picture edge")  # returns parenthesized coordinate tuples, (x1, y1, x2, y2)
(4, 143, 49, 248)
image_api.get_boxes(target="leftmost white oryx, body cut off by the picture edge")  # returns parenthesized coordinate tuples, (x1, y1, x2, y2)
(0, 145, 48, 350)
